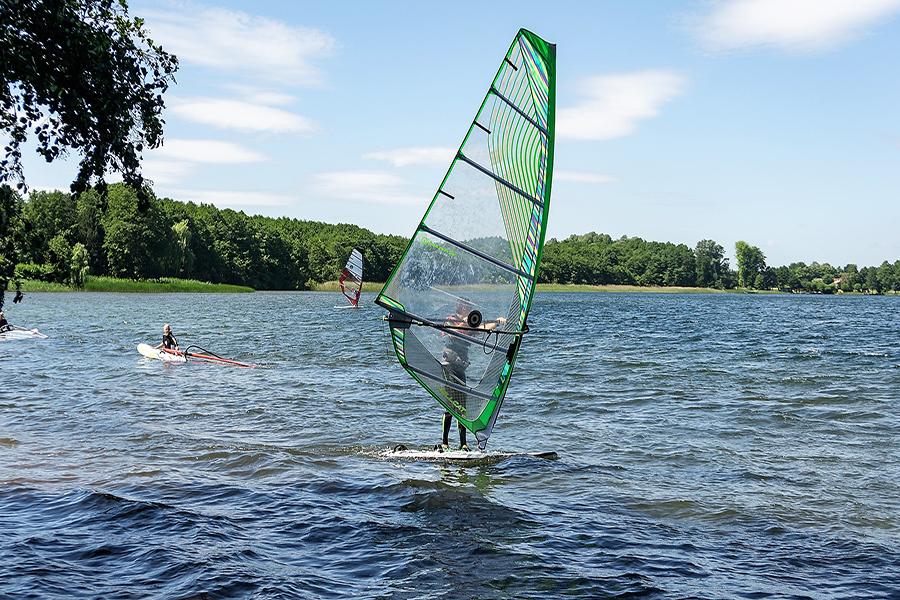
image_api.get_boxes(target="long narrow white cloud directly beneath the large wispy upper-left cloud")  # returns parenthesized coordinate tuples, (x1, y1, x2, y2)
(169, 97, 313, 133)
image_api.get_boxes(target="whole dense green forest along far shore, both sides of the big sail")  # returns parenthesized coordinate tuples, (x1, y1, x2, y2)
(0, 184, 900, 293)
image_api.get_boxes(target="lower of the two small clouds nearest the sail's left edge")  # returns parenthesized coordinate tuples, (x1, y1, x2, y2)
(313, 171, 426, 205)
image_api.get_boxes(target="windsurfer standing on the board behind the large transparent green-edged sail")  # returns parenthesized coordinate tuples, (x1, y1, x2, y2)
(440, 298, 506, 452)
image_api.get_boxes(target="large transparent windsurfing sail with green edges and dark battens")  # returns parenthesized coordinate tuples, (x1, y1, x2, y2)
(376, 29, 556, 449)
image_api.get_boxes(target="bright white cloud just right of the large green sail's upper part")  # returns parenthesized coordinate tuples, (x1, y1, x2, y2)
(557, 71, 685, 140)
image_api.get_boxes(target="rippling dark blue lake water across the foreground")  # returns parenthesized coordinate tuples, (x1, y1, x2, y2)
(0, 293, 900, 600)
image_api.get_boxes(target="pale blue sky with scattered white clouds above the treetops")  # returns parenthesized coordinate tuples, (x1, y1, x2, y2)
(19, 0, 900, 265)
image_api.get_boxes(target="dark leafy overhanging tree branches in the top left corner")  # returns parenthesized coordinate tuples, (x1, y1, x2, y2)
(0, 0, 178, 197)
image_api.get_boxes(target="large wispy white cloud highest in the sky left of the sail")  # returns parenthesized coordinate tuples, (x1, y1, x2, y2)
(144, 3, 336, 85)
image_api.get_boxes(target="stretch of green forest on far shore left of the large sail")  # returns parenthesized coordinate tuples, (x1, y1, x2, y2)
(0, 184, 407, 290)
